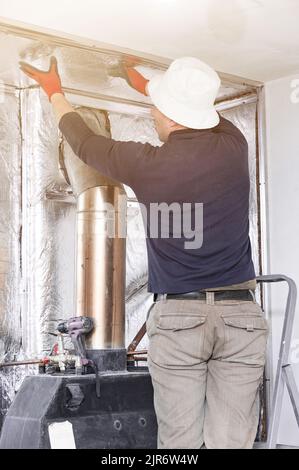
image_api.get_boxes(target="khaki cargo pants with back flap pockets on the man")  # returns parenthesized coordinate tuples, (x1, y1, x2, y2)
(146, 292, 269, 449)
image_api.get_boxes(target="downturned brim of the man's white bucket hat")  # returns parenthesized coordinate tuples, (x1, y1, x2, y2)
(147, 74, 220, 129)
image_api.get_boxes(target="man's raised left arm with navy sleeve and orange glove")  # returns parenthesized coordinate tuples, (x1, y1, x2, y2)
(20, 57, 155, 187)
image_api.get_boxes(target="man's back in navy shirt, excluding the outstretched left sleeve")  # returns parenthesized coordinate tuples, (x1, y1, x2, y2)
(132, 118, 255, 293)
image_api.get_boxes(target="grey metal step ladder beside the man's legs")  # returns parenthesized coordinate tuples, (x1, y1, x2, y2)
(256, 274, 299, 449)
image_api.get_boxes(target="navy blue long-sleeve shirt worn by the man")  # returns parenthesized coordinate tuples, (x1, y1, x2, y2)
(59, 112, 255, 293)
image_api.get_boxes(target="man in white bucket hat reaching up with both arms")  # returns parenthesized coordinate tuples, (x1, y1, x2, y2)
(21, 57, 268, 449)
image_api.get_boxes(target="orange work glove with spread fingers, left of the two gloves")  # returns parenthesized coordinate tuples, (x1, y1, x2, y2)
(19, 57, 64, 101)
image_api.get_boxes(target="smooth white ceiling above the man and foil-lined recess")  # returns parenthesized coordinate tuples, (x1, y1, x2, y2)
(0, 0, 299, 81)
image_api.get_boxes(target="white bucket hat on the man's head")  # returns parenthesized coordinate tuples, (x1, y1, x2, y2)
(147, 57, 221, 129)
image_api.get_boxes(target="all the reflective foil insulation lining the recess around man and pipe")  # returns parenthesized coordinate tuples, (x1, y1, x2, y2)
(0, 20, 260, 422)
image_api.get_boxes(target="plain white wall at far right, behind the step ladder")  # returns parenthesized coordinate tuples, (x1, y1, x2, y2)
(265, 74, 299, 446)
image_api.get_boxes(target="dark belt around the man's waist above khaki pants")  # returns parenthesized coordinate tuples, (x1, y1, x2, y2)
(154, 289, 255, 302)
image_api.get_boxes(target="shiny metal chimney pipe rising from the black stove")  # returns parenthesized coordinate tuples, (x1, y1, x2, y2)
(60, 108, 126, 350)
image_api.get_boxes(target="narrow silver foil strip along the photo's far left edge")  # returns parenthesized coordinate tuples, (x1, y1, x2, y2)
(0, 92, 23, 423)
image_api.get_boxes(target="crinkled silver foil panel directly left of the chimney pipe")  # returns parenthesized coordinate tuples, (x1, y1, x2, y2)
(22, 89, 76, 357)
